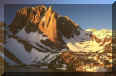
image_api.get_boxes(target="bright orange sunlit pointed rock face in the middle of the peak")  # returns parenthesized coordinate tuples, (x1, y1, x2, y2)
(38, 8, 58, 43)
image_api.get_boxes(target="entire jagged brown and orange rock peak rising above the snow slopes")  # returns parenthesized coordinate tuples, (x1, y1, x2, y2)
(9, 5, 79, 44)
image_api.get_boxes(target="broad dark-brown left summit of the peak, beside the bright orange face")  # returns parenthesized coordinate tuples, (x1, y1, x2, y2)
(9, 5, 47, 34)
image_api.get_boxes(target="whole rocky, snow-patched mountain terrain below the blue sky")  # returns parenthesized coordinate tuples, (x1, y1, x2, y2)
(0, 5, 112, 72)
